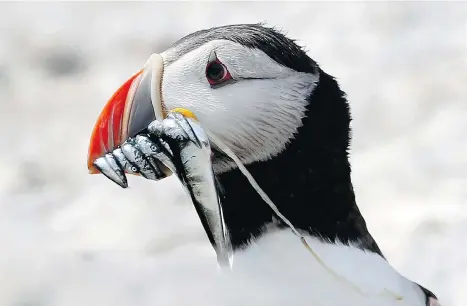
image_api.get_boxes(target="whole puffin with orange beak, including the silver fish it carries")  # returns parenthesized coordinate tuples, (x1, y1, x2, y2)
(88, 24, 440, 306)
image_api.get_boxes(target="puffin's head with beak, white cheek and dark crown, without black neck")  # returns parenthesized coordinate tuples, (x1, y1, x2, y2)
(88, 24, 326, 173)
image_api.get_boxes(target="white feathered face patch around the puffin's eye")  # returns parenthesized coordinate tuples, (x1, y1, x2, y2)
(161, 40, 319, 172)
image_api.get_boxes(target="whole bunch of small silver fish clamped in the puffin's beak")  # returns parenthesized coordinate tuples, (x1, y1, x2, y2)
(94, 113, 233, 266)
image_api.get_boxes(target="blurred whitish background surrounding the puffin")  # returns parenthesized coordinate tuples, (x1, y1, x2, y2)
(0, 2, 467, 306)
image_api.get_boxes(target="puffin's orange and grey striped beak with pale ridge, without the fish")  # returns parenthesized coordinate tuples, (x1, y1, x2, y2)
(87, 54, 165, 174)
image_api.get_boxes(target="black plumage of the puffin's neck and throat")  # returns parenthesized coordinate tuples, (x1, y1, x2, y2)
(218, 70, 381, 255)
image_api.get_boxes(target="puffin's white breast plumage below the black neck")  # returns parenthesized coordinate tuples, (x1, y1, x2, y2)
(155, 229, 425, 306)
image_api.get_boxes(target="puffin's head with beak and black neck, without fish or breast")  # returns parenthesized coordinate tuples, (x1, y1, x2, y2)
(88, 20, 356, 253)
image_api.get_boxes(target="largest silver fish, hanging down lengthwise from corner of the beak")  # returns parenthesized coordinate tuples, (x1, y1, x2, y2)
(148, 113, 233, 266)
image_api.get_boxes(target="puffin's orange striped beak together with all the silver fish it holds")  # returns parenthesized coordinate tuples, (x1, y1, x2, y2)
(87, 54, 232, 266)
